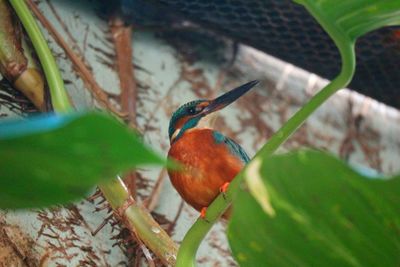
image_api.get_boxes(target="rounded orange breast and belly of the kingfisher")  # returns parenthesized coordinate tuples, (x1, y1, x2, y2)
(168, 129, 243, 213)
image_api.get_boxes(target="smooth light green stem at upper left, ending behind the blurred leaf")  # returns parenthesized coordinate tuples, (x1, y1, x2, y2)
(9, 0, 72, 112)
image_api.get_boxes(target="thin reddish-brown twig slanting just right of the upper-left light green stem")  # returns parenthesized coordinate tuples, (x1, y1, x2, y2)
(26, 0, 126, 117)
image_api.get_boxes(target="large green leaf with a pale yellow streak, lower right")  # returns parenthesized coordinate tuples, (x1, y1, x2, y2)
(228, 151, 400, 266)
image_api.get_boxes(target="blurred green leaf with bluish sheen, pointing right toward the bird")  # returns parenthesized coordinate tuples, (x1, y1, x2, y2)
(0, 113, 165, 209)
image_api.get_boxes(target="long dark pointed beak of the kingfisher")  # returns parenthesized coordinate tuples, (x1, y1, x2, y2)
(202, 81, 259, 115)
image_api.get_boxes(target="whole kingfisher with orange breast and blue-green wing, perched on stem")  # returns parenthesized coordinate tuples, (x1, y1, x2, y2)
(168, 81, 258, 218)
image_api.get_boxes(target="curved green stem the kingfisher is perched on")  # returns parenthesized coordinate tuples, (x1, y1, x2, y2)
(176, 14, 355, 267)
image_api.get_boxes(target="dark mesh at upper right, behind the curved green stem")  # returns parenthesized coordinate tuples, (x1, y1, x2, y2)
(122, 0, 400, 108)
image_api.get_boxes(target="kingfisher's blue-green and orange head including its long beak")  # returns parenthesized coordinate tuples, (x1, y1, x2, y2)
(168, 81, 258, 143)
